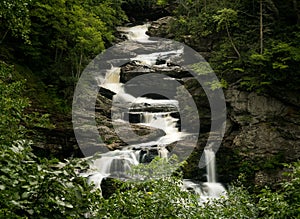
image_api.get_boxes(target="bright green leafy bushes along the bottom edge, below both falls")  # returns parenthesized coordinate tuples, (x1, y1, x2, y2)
(94, 162, 300, 219)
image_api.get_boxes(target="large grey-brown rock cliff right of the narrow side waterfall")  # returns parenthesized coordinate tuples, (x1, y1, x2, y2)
(218, 86, 300, 186)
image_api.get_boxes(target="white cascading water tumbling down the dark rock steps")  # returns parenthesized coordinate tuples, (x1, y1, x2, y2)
(84, 24, 225, 202)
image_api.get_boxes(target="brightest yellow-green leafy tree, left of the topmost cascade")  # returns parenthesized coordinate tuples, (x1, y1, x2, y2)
(24, 0, 126, 78)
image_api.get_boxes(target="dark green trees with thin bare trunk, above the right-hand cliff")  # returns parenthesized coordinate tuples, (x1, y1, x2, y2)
(165, 0, 300, 92)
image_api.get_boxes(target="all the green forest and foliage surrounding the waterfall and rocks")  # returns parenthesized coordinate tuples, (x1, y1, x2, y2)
(0, 0, 300, 218)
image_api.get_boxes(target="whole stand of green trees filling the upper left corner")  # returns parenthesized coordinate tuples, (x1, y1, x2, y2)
(0, 0, 127, 108)
